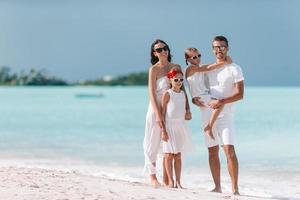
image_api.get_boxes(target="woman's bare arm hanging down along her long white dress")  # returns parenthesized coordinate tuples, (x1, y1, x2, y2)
(148, 67, 163, 128)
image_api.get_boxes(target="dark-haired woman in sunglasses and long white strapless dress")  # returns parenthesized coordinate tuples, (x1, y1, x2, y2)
(143, 39, 191, 187)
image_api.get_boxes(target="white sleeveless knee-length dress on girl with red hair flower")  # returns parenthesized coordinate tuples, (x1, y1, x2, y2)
(163, 89, 194, 154)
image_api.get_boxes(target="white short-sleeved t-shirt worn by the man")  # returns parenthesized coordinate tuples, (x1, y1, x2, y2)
(207, 63, 244, 115)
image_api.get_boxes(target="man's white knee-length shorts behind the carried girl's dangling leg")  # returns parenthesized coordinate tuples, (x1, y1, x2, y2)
(200, 95, 234, 148)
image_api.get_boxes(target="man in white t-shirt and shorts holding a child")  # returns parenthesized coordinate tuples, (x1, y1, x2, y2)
(202, 36, 244, 195)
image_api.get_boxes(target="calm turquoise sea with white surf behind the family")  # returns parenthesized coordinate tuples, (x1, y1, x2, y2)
(0, 87, 300, 199)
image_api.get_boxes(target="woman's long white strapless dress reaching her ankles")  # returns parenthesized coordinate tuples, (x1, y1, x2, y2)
(143, 76, 170, 175)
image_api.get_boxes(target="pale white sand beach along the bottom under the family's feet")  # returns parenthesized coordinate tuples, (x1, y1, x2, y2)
(0, 166, 274, 200)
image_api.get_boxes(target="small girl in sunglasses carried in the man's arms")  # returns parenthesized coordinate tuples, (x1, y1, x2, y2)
(185, 48, 232, 139)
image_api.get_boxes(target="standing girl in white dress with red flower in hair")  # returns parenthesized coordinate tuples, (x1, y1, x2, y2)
(161, 69, 192, 188)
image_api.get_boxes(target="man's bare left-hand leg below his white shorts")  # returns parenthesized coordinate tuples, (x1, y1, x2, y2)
(208, 146, 222, 193)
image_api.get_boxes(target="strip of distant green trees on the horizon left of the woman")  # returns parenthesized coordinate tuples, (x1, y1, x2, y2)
(0, 66, 148, 86)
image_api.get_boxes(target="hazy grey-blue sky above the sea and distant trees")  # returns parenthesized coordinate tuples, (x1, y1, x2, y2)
(0, 0, 300, 86)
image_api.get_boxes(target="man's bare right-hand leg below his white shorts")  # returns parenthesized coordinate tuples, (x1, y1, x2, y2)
(223, 145, 240, 195)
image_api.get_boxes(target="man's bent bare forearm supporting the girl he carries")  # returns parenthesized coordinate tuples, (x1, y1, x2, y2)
(208, 81, 244, 109)
